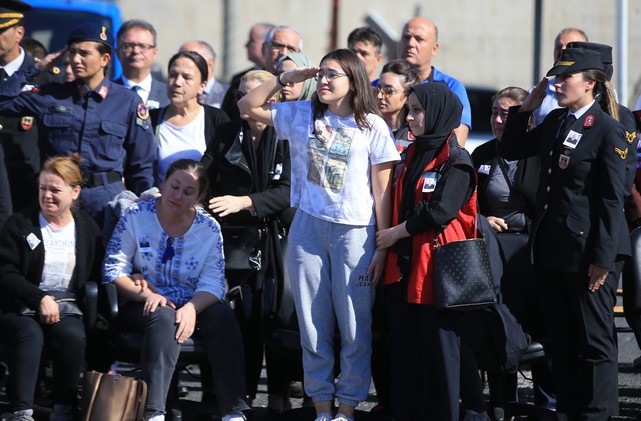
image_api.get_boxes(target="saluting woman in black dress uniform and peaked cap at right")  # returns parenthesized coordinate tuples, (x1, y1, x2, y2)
(500, 48, 634, 420)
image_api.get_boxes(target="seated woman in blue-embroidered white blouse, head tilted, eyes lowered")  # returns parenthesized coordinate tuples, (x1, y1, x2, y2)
(103, 159, 249, 421)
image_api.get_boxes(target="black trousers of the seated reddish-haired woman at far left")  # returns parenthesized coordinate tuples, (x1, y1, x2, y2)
(0, 313, 86, 411)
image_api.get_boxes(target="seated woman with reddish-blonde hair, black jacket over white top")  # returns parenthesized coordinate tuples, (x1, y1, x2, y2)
(0, 154, 103, 421)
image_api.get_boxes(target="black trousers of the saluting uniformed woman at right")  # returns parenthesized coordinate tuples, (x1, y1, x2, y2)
(538, 262, 623, 421)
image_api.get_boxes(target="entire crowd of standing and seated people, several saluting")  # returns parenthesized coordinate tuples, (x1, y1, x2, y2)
(0, 0, 641, 421)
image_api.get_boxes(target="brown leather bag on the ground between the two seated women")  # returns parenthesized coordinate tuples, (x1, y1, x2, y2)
(82, 371, 147, 421)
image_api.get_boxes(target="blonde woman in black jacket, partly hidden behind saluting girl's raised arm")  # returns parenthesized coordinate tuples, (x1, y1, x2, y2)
(201, 70, 290, 404)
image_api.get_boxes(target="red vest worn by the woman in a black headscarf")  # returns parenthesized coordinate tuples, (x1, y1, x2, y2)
(383, 139, 477, 305)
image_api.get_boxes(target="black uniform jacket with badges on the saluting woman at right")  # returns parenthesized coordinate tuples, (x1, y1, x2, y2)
(500, 103, 635, 273)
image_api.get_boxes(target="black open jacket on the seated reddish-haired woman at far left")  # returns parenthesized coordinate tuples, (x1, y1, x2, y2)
(0, 209, 104, 313)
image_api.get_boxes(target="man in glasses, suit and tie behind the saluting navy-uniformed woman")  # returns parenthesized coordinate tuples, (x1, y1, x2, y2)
(115, 19, 169, 109)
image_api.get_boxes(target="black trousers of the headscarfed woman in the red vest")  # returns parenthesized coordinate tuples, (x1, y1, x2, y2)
(385, 284, 461, 421)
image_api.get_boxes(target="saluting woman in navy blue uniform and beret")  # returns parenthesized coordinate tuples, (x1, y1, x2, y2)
(0, 23, 155, 223)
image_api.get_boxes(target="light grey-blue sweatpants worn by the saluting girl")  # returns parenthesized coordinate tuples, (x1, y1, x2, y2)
(287, 210, 376, 406)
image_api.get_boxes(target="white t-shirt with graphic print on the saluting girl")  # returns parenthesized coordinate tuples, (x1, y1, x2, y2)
(272, 101, 400, 226)
